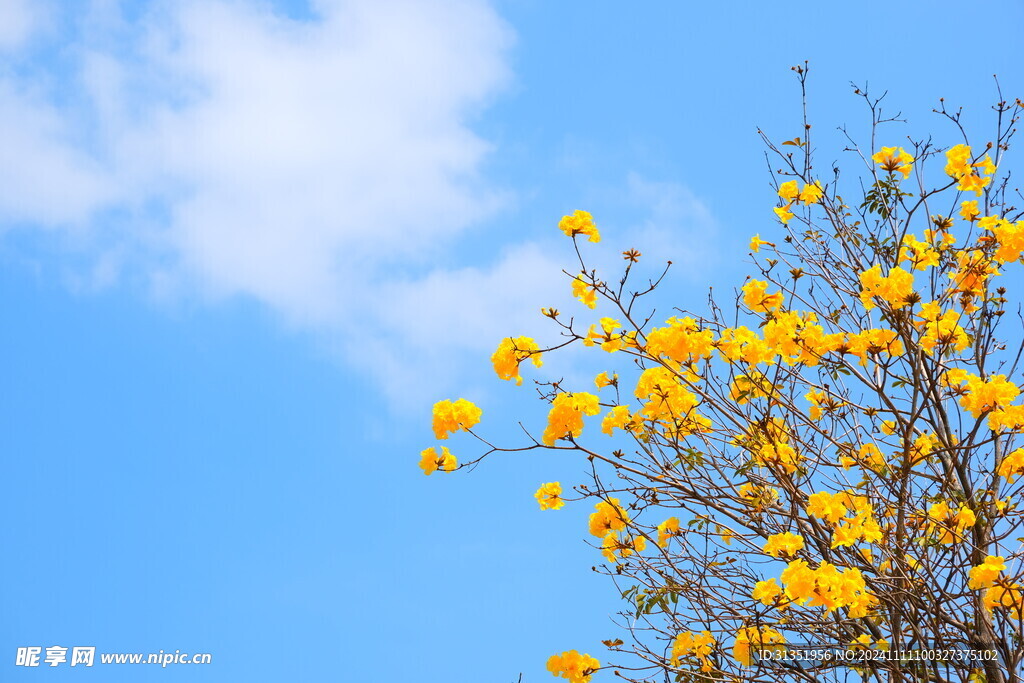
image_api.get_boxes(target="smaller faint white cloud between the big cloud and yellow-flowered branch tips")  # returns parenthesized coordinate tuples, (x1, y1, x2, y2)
(346, 244, 570, 407)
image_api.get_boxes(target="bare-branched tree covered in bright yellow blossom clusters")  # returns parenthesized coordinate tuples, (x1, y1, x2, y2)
(421, 67, 1024, 683)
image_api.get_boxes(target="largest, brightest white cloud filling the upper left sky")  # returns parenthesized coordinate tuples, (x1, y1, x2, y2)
(0, 0, 512, 324)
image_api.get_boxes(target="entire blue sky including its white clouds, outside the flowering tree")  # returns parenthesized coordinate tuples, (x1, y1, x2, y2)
(0, 0, 1024, 682)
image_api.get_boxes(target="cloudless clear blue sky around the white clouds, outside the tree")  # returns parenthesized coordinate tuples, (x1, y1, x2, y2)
(0, 0, 1024, 683)
